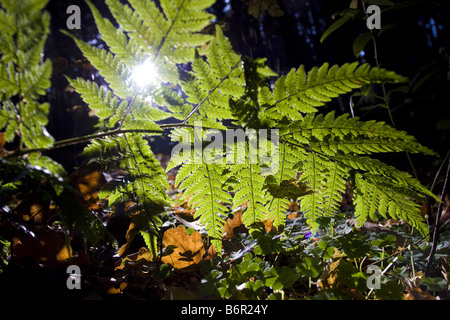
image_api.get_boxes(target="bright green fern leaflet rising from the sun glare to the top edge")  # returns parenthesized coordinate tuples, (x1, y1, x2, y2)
(105, 0, 214, 83)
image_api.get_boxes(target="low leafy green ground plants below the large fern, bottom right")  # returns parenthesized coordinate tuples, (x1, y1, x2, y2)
(198, 214, 448, 300)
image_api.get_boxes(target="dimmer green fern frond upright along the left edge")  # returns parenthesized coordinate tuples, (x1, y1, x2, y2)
(0, 0, 53, 149)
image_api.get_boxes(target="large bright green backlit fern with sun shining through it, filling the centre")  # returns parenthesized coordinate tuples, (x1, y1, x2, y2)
(62, 0, 434, 253)
